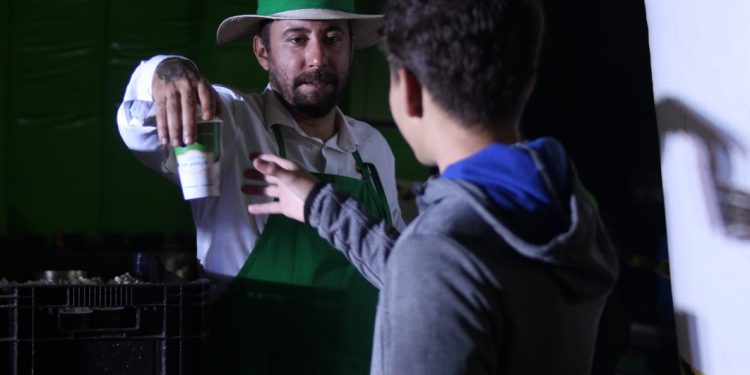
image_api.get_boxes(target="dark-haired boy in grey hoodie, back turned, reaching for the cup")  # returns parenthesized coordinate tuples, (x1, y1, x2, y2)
(244, 0, 617, 375)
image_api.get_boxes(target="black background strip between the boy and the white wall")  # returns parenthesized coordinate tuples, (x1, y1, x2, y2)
(523, 0, 678, 374)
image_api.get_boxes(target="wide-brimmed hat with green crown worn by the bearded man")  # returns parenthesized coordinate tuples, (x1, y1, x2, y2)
(216, 0, 383, 48)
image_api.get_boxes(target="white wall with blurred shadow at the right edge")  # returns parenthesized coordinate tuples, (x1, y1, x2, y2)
(645, 0, 750, 375)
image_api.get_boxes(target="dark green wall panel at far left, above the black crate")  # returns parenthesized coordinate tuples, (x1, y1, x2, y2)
(6, 0, 104, 234)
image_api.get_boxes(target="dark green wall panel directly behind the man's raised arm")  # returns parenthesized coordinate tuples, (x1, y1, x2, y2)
(100, 0, 205, 234)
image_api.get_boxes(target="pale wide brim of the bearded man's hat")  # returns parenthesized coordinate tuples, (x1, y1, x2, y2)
(216, 9, 383, 49)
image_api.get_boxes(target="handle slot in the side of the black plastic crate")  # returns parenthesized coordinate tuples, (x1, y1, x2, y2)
(57, 306, 141, 333)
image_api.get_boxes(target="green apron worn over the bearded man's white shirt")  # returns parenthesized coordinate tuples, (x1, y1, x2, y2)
(209, 126, 391, 375)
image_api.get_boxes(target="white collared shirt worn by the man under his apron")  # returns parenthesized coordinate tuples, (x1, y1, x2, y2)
(117, 56, 404, 276)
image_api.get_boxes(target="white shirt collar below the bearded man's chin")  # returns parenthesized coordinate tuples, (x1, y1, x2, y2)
(261, 88, 359, 153)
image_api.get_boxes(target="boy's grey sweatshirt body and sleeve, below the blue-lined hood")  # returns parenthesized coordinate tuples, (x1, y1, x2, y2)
(305, 140, 617, 375)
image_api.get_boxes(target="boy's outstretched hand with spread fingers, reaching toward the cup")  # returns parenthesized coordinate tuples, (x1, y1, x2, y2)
(242, 154, 319, 222)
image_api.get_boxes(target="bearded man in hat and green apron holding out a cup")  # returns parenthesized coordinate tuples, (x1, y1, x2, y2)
(117, 0, 403, 374)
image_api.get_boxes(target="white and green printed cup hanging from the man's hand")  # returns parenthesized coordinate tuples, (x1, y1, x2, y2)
(174, 120, 222, 200)
